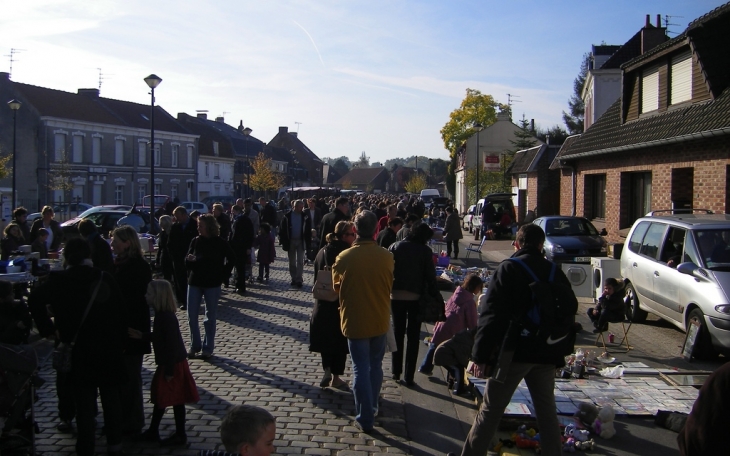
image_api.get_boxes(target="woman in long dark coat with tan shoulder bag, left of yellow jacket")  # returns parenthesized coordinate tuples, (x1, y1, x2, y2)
(309, 221, 355, 391)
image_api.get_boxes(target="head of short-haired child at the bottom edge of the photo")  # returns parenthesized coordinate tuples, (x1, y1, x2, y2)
(198, 405, 276, 456)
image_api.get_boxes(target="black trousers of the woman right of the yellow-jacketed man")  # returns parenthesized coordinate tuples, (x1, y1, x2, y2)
(390, 300, 421, 382)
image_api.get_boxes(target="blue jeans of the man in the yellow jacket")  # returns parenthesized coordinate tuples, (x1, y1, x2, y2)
(347, 334, 385, 431)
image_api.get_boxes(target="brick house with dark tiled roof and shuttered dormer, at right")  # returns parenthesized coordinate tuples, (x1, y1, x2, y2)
(551, 3, 730, 242)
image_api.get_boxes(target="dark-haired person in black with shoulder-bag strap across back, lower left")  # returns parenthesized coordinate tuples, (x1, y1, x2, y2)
(28, 238, 127, 456)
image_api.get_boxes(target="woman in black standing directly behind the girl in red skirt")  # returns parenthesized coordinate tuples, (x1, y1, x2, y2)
(112, 226, 152, 435)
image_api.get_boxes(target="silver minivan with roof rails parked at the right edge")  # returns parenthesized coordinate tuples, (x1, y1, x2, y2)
(621, 210, 730, 359)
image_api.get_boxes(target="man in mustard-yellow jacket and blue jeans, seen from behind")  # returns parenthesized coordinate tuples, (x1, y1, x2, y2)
(332, 211, 394, 433)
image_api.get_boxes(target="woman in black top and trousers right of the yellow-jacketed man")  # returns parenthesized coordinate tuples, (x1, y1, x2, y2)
(389, 223, 443, 386)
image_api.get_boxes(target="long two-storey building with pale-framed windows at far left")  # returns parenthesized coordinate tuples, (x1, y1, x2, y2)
(0, 73, 198, 211)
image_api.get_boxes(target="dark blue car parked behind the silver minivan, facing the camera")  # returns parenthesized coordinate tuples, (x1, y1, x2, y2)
(532, 215, 608, 263)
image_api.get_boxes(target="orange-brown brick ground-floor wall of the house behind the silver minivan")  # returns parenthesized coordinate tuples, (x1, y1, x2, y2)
(560, 137, 730, 242)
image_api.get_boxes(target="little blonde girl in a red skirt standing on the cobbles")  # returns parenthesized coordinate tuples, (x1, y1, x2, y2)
(128, 280, 200, 446)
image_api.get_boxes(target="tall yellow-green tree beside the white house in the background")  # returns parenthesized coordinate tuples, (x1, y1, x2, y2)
(441, 89, 500, 194)
